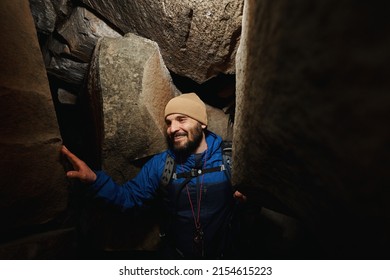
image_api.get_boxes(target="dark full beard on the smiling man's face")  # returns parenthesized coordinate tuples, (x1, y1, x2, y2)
(167, 123, 203, 156)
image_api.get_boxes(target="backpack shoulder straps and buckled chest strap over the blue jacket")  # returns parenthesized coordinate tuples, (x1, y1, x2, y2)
(160, 141, 232, 188)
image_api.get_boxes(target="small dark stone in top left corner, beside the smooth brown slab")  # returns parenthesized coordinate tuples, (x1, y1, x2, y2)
(29, 0, 57, 34)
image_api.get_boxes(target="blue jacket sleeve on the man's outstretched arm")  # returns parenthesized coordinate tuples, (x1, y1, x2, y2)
(91, 154, 164, 211)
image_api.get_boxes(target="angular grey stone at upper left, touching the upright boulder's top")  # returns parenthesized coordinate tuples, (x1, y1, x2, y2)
(57, 7, 121, 62)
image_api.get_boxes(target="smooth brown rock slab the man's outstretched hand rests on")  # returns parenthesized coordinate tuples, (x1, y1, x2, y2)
(0, 0, 67, 233)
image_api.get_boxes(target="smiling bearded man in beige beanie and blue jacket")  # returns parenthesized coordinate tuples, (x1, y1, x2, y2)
(62, 93, 246, 258)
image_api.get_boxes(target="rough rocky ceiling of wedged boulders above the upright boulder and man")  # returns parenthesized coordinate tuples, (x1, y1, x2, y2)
(30, 0, 243, 97)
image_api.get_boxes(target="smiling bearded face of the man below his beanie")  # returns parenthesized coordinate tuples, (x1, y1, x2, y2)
(165, 114, 203, 154)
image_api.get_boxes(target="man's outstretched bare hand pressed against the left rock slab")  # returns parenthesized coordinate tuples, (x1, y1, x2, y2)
(61, 146, 96, 184)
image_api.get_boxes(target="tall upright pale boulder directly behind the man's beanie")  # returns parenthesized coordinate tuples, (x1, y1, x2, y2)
(88, 33, 178, 181)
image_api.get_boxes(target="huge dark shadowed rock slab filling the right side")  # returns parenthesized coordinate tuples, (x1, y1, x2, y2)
(233, 1, 390, 258)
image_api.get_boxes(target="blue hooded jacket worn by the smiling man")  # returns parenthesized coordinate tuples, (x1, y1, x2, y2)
(92, 131, 235, 258)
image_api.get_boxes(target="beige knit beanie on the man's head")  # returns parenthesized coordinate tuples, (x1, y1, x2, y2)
(164, 92, 207, 125)
